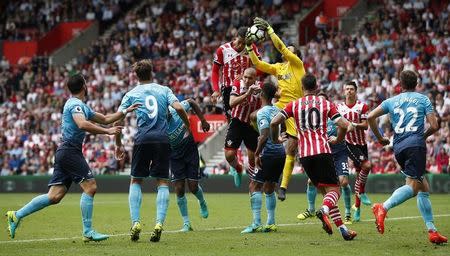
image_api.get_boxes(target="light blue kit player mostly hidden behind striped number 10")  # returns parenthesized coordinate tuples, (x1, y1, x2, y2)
(297, 92, 352, 225)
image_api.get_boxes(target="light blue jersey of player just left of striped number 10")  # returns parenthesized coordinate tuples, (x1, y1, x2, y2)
(256, 106, 285, 156)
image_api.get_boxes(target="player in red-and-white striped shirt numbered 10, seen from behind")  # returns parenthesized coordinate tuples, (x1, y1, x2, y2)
(270, 74, 356, 240)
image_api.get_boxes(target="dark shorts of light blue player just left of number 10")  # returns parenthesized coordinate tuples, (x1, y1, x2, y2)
(253, 155, 286, 183)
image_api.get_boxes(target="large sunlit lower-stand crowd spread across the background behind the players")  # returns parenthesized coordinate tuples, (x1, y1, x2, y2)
(0, 0, 450, 175)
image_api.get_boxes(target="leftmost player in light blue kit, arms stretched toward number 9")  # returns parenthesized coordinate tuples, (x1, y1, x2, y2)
(6, 74, 139, 242)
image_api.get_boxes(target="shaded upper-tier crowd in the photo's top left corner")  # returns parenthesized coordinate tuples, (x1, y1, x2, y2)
(0, 0, 137, 41)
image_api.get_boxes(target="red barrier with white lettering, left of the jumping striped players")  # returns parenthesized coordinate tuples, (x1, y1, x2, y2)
(189, 115, 227, 142)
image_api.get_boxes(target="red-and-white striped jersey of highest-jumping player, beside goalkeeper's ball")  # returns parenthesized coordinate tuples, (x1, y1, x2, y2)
(214, 42, 259, 88)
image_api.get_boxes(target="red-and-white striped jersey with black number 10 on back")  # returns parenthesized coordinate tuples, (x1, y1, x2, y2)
(281, 95, 341, 158)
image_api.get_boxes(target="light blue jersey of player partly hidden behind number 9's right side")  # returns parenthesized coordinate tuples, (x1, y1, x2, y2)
(167, 100, 191, 149)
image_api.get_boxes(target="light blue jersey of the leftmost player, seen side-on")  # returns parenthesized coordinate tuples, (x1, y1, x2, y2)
(60, 97, 95, 149)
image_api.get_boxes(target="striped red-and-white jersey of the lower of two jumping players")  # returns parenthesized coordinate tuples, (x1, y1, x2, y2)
(230, 79, 262, 123)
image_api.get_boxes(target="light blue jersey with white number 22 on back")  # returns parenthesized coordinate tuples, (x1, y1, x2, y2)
(381, 92, 433, 154)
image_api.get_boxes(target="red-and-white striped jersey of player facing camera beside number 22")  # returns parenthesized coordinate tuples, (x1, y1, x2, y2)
(337, 101, 369, 145)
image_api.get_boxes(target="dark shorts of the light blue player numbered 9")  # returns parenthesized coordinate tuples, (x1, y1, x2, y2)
(131, 143, 170, 179)
